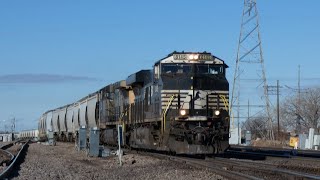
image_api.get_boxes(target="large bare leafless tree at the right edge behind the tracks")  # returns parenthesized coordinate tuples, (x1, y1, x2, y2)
(280, 88, 320, 133)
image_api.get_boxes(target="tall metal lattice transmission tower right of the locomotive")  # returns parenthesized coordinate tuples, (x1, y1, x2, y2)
(231, 0, 274, 140)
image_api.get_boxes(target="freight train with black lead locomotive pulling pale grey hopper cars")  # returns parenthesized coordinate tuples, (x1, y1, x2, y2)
(39, 52, 230, 154)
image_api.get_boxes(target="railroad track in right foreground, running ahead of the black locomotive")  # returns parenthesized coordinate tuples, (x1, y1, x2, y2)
(140, 152, 320, 180)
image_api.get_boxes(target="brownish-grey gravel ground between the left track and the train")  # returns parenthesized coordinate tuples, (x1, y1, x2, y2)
(13, 143, 223, 180)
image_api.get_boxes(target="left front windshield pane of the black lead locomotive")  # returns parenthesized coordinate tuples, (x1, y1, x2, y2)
(161, 64, 192, 74)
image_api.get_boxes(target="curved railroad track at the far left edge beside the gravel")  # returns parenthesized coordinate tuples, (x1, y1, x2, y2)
(0, 141, 29, 179)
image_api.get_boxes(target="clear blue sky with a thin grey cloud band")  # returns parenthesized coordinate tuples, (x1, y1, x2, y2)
(0, 0, 320, 131)
